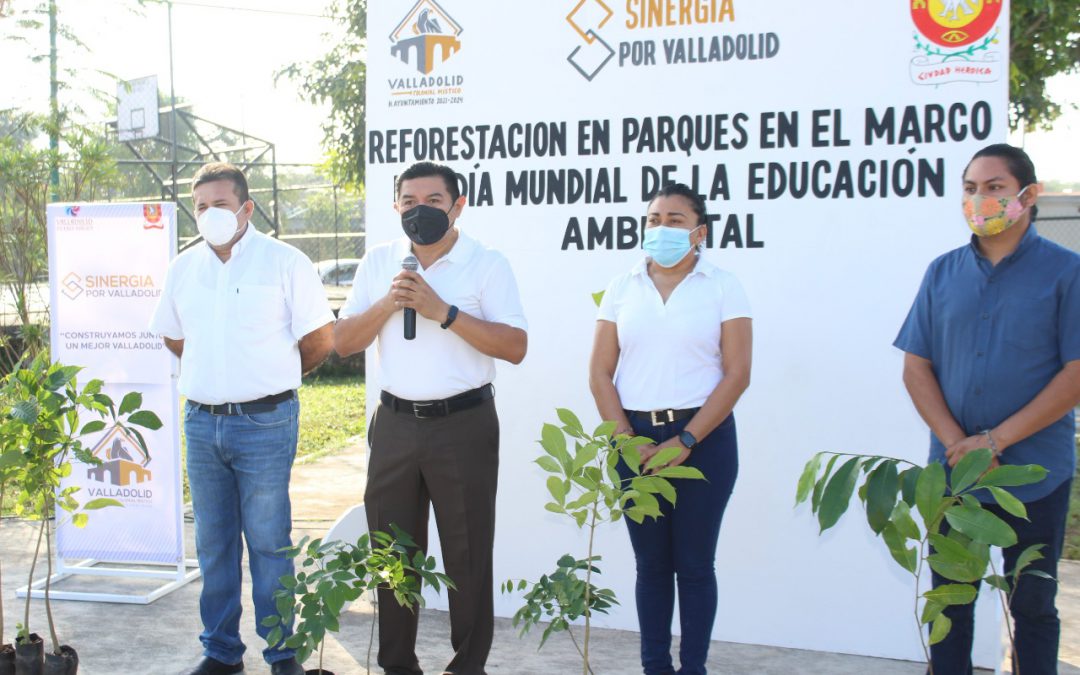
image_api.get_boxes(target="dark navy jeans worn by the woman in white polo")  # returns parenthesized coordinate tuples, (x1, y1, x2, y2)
(619, 415, 739, 675)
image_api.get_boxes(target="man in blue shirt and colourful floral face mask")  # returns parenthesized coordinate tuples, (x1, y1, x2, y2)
(894, 144, 1080, 675)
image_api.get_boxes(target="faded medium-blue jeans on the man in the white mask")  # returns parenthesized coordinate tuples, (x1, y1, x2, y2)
(184, 397, 300, 663)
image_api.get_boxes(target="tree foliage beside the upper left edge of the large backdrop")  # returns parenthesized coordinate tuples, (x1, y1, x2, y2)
(278, 0, 367, 190)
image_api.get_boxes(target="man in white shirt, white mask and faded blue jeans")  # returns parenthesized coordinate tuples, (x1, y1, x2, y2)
(150, 163, 334, 675)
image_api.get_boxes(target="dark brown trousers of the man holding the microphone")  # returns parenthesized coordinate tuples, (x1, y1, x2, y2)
(364, 400, 499, 675)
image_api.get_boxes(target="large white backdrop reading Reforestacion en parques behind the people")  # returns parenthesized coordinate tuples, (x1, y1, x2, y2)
(365, 0, 1009, 664)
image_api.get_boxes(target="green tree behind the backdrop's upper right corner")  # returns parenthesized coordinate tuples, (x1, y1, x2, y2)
(1009, 0, 1080, 131)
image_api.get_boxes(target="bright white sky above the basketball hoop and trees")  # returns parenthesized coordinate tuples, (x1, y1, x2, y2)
(0, 0, 1080, 184)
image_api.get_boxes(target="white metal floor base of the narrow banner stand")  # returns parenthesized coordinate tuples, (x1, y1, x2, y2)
(15, 559, 202, 605)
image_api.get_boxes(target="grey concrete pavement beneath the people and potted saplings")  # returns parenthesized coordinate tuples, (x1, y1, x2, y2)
(0, 448, 1080, 675)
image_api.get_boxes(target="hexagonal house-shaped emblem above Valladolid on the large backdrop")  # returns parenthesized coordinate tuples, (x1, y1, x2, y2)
(390, 0, 462, 75)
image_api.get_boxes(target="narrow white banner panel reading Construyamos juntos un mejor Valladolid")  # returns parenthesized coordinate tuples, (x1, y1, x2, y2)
(48, 203, 184, 564)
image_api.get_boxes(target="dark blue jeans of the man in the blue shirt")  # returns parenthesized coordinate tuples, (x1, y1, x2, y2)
(930, 480, 1072, 675)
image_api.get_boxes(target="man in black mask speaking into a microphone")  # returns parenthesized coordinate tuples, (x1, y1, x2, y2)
(334, 162, 527, 675)
